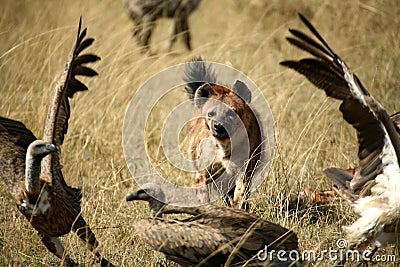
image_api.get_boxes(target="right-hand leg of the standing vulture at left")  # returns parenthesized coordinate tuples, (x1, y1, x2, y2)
(72, 216, 114, 266)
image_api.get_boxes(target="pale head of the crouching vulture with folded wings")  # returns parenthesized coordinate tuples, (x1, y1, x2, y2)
(126, 183, 165, 218)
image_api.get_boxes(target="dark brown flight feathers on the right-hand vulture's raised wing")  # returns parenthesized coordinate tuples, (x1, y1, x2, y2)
(280, 15, 392, 193)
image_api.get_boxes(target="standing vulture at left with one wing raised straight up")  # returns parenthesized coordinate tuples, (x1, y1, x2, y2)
(0, 19, 113, 266)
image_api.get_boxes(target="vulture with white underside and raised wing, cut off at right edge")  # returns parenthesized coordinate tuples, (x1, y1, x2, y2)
(280, 14, 400, 263)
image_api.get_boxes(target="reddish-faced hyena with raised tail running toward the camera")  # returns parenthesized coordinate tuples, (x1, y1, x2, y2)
(183, 58, 262, 207)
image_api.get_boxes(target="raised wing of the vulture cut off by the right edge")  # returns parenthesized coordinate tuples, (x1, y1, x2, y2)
(280, 15, 400, 199)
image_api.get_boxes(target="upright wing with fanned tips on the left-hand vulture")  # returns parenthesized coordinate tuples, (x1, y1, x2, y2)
(42, 18, 100, 185)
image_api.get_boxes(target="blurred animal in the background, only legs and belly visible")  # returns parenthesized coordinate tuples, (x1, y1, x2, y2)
(124, 0, 201, 50)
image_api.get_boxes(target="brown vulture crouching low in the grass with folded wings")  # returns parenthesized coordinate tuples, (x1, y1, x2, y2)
(126, 183, 301, 267)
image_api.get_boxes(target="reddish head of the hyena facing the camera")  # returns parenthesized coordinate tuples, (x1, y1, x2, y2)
(194, 80, 251, 141)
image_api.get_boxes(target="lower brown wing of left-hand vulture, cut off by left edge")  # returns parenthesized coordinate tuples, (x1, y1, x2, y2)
(0, 117, 36, 196)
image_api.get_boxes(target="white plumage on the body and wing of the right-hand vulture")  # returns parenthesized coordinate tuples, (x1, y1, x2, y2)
(339, 57, 400, 251)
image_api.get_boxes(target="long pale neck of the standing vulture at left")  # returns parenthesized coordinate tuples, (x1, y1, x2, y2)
(25, 152, 42, 196)
